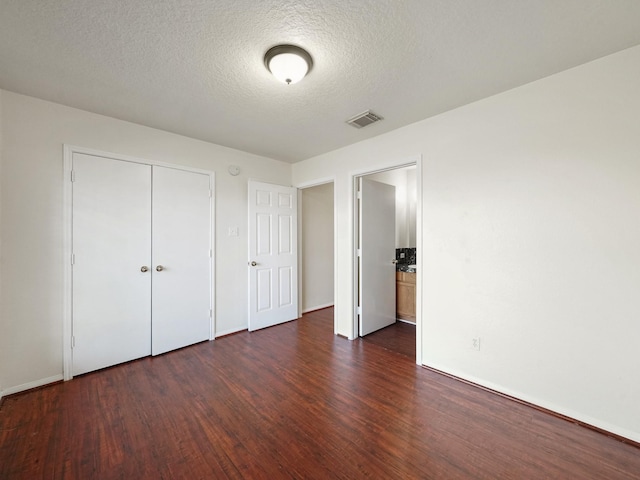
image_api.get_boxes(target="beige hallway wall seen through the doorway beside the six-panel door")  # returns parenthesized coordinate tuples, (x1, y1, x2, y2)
(299, 183, 334, 312)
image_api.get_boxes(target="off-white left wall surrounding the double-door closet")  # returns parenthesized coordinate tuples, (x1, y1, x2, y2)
(0, 91, 291, 393)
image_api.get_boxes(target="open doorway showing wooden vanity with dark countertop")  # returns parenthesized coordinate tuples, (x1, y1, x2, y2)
(354, 161, 421, 363)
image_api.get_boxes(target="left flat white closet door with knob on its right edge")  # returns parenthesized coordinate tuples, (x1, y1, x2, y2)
(72, 153, 151, 375)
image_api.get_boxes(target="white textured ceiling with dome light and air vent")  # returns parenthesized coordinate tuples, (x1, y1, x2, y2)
(0, 0, 640, 162)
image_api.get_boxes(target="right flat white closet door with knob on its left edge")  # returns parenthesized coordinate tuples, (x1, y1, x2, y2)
(151, 166, 211, 355)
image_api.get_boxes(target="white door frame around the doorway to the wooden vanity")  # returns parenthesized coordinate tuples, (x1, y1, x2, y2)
(349, 155, 424, 365)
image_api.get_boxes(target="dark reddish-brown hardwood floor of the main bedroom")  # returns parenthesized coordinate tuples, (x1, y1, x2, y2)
(0, 309, 640, 480)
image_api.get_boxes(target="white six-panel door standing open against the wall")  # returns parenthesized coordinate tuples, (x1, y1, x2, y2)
(248, 181, 298, 331)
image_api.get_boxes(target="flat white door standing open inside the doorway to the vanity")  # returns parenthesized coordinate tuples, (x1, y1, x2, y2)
(359, 178, 396, 336)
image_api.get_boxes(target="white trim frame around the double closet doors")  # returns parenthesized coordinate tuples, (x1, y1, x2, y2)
(60, 144, 216, 381)
